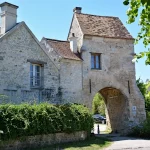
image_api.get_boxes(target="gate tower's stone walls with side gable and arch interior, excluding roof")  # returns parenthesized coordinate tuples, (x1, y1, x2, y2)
(69, 14, 146, 133)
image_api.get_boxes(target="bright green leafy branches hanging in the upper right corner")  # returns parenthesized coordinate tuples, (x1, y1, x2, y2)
(123, 0, 150, 65)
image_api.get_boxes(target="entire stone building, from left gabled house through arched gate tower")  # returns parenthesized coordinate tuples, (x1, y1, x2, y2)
(0, 2, 146, 132)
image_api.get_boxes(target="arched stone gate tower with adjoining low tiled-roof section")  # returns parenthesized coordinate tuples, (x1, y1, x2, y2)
(41, 7, 146, 133)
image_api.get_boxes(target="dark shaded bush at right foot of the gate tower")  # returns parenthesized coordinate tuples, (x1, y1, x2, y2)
(129, 119, 150, 138)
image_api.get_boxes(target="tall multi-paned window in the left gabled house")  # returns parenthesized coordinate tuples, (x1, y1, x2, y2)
(30, 64, 41, 87)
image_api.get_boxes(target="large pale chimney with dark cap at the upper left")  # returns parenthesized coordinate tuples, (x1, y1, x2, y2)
(0, 2, 18, 34)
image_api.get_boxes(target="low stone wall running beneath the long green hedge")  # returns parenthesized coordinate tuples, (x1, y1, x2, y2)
(0, 131, 87, 150)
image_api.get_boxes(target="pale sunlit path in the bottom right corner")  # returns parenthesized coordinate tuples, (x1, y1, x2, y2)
(104, 137, 150, 150)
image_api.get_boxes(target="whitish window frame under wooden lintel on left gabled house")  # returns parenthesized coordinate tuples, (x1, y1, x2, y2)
(30, 63, 42, 88)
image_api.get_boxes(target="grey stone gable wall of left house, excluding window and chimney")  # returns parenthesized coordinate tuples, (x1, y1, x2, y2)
(0, 25, 59, 103)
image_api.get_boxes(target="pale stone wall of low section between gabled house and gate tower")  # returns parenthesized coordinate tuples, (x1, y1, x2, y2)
(60, 59, 82, 103)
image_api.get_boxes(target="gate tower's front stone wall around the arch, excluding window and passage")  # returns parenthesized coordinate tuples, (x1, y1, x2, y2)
(82, 36, 146, 133)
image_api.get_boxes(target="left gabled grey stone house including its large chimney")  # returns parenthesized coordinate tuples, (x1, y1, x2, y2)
(0, 2, 59, 103)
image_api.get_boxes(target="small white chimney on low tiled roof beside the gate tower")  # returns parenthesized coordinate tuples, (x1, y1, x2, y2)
(69, 33, 78, 53)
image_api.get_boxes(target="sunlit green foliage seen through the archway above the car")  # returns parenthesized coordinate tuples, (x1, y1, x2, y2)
(92, 93, 105, 116)
